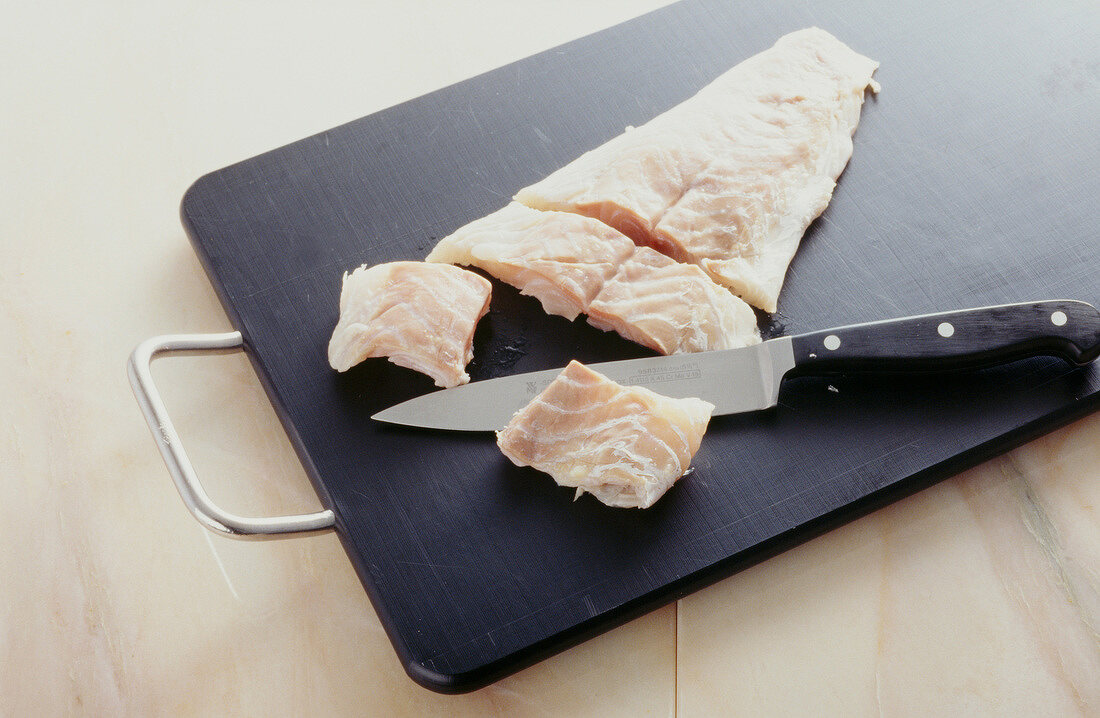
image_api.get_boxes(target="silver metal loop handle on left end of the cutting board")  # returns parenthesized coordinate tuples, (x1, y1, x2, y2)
(127, 332, 336, 539)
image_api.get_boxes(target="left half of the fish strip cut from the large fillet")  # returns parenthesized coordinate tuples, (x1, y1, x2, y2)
(427, 202, 634, 320)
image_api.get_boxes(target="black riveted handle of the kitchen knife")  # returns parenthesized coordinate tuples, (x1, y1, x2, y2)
(791, 299, 1100, 375)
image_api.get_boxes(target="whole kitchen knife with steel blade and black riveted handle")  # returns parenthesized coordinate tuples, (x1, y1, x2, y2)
(372, 299, 1100, 431)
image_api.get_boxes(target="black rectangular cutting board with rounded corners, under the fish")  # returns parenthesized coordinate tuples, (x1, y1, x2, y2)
(182, 0, 1100, 692)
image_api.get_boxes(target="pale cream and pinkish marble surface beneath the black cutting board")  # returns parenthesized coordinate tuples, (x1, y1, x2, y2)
(0, 0, 1100, 716)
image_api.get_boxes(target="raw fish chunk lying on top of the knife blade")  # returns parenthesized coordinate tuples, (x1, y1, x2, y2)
(496, 362, 714, 508)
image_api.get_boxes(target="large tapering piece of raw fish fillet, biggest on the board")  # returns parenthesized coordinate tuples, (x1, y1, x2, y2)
(515, 27, 879, 311)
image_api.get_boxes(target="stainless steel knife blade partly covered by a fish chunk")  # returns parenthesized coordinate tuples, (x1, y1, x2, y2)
(372, 336, 794, 431)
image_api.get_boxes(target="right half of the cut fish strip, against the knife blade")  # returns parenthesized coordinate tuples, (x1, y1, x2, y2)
(589, 246, 760, 354)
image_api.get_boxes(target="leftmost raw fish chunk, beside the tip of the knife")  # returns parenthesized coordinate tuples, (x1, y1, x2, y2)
(329, 262, 492, 387)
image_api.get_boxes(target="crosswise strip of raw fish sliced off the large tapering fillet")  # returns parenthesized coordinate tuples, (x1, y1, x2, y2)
(428, 202, 760, 354)
